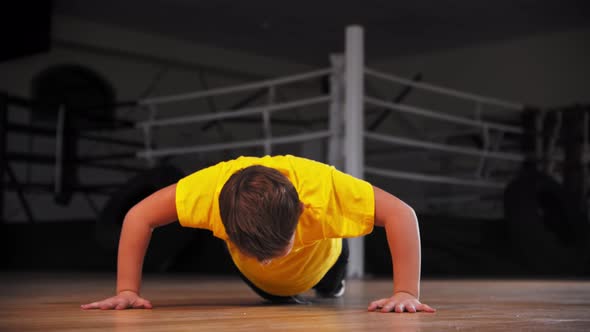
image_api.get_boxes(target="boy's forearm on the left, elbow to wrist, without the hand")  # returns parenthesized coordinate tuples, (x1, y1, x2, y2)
(117, 210, 152, 294)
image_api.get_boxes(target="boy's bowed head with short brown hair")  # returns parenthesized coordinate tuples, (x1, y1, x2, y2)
(219, 165, 301, 262)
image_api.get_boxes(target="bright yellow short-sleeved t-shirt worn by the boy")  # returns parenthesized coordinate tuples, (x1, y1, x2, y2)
(176, 155, 375, 296)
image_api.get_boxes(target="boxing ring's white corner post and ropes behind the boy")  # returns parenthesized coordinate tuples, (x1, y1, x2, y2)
(136, 26, 525, 277)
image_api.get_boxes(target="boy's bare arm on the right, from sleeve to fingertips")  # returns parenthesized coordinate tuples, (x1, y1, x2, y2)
(368, 187, 435, 312)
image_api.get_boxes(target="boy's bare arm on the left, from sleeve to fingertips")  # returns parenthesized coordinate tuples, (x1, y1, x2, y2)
(82, 184, 178, 309)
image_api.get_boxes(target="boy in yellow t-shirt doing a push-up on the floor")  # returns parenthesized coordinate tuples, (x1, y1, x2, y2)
(82, 155, 434, 312)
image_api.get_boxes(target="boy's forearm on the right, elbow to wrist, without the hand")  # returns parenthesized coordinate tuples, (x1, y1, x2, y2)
(385, 206, 421, 298)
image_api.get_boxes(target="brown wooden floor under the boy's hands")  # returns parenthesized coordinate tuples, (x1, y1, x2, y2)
(0, 272, 590, 332)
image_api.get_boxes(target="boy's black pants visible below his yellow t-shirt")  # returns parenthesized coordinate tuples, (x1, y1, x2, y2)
(236, 239, 349, 303)
